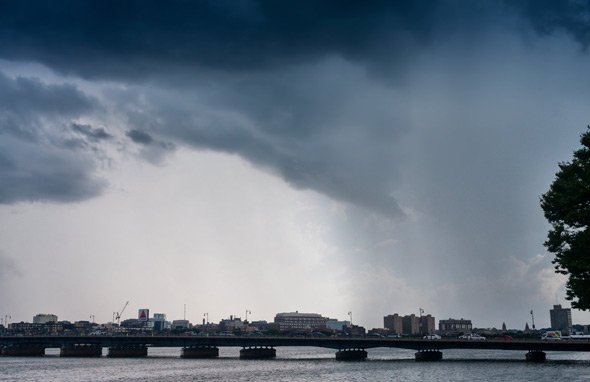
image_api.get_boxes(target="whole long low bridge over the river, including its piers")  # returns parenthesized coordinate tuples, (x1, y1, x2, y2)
(0, 335, 590, 362)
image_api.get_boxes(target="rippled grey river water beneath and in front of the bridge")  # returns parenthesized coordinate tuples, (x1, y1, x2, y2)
(0, 347, 590, 382)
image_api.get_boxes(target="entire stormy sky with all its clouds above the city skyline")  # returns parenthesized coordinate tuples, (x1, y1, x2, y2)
(0, 0, 590, 328)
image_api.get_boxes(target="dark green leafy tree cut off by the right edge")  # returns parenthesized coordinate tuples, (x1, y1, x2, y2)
(541, 126, 590, 310)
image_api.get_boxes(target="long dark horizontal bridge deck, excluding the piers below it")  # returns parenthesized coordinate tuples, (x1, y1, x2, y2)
(0, 335, 590, 352)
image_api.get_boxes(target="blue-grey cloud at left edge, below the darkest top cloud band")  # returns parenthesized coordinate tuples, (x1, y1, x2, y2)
(0, 73, 104, 204)
